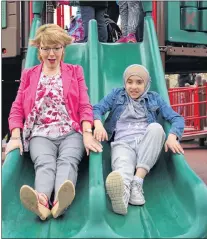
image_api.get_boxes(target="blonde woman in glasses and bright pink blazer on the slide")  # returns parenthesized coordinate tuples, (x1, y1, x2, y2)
(6, 24, 102, 220)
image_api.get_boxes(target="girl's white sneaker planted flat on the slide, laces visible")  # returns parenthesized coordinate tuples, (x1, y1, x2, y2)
(129, 180, 145, 205)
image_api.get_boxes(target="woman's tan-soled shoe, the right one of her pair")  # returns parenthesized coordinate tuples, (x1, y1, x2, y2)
(51, 180, 75, 218)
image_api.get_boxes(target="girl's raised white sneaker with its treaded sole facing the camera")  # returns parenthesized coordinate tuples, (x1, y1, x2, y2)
(106, 171, 130, 215)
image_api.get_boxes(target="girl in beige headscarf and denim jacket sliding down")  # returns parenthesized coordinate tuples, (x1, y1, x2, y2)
(93, 65, 184, 215)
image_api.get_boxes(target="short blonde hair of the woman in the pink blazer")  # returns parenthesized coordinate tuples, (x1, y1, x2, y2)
(30, 24, 73, 61)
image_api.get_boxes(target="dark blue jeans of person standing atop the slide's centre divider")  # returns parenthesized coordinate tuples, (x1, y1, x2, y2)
(80, 6, 108, 42)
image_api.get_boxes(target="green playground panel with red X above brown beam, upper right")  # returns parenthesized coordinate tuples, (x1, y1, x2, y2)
(153, 1, 207, 74)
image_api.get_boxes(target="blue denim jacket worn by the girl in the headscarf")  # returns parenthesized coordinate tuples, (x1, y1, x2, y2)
(93, 88, 185, 141)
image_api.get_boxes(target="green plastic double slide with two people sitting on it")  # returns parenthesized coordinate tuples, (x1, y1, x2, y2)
(2, 15, 207, 238)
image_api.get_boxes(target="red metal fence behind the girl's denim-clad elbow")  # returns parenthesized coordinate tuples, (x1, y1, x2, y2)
(168, 83, 207, 138)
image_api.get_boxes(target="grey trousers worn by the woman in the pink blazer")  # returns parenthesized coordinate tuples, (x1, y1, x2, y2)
(30, 131, 85, 199)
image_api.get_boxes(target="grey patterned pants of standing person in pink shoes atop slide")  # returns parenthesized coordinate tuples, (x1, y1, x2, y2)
(118, 1, 141, 36)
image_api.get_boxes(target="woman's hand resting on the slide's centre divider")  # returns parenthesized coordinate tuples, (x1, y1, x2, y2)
(83, 132, 103, 156)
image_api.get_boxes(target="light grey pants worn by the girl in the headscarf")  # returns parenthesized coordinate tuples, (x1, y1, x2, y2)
(111, 123, 165, 186)
